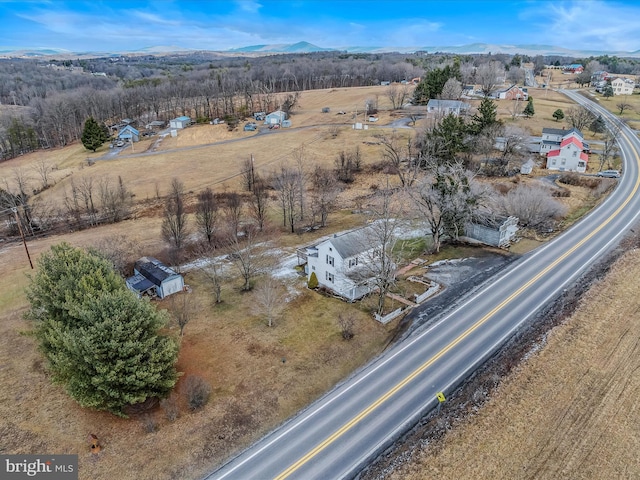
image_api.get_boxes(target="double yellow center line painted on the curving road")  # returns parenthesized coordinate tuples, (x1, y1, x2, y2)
(275, 124, 640, 480)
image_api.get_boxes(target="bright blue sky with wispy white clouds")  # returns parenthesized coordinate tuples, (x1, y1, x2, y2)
(0, 0, 640, 52)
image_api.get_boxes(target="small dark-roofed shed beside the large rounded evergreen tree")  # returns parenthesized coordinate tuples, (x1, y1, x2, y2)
(126, 257, 184, 298)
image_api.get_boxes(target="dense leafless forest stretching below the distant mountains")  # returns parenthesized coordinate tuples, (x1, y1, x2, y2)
(0, 52, 640, 160)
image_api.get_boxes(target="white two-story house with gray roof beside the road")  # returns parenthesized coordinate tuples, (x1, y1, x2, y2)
(298, 226, 380, 301)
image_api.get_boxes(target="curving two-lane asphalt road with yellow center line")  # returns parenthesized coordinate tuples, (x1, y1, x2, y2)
(207, 92, 640, 480)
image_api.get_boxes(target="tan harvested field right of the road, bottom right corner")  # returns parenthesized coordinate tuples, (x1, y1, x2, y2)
(388, 249, 640, 480)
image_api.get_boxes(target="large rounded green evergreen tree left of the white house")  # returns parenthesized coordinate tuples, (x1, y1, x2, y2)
(27, 243, 178, 416)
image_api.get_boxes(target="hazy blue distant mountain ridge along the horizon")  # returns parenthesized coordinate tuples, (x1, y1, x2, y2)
(0, 41, 640, 58)
